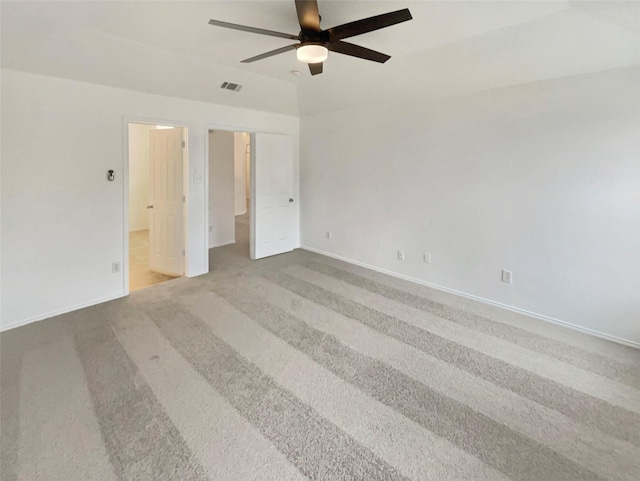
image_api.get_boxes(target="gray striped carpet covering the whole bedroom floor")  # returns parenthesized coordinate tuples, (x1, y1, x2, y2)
(0, 219, 640, 481)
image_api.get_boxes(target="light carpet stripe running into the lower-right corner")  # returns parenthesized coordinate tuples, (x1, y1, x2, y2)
(229, 276, 640, 481)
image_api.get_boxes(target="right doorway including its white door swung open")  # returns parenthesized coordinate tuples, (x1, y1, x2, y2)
(207, 130, 297, 270)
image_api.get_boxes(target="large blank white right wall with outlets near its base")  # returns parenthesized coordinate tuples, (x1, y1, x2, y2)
(301, 68, 640, 343)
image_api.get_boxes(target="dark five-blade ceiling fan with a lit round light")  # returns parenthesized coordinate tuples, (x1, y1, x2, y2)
(209, 0, 413, 75)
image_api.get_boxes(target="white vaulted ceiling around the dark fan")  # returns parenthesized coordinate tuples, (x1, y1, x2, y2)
(2, 0, 640, 115)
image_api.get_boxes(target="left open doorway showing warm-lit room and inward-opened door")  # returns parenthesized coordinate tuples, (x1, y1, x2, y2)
(128, 122, 187, 292)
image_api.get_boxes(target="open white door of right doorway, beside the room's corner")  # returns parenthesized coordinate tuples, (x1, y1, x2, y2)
(250, 134, 297, 259)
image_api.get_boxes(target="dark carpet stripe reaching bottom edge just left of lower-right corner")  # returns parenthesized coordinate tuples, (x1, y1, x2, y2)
(214, 274, 604, 481)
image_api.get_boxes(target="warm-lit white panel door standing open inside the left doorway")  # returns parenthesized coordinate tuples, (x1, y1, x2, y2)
(149, 128, 184, 276)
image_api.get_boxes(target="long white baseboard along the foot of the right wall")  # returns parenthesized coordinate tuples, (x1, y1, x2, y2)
(300, 246, 640, 349)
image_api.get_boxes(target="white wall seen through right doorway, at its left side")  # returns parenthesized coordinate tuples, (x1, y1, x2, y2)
(209, 130, 236, 247)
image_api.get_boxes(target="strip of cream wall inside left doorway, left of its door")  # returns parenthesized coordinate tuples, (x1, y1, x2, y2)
(129, 124, 156, 232)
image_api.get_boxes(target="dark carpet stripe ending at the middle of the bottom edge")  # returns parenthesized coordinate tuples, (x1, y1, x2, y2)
(142, 301, 406, 480)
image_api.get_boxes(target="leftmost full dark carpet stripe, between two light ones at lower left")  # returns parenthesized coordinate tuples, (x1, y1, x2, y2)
(76, 325, 207, 481)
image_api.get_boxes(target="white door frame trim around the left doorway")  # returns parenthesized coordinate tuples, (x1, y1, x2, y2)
(121, 116, 189, 296)
